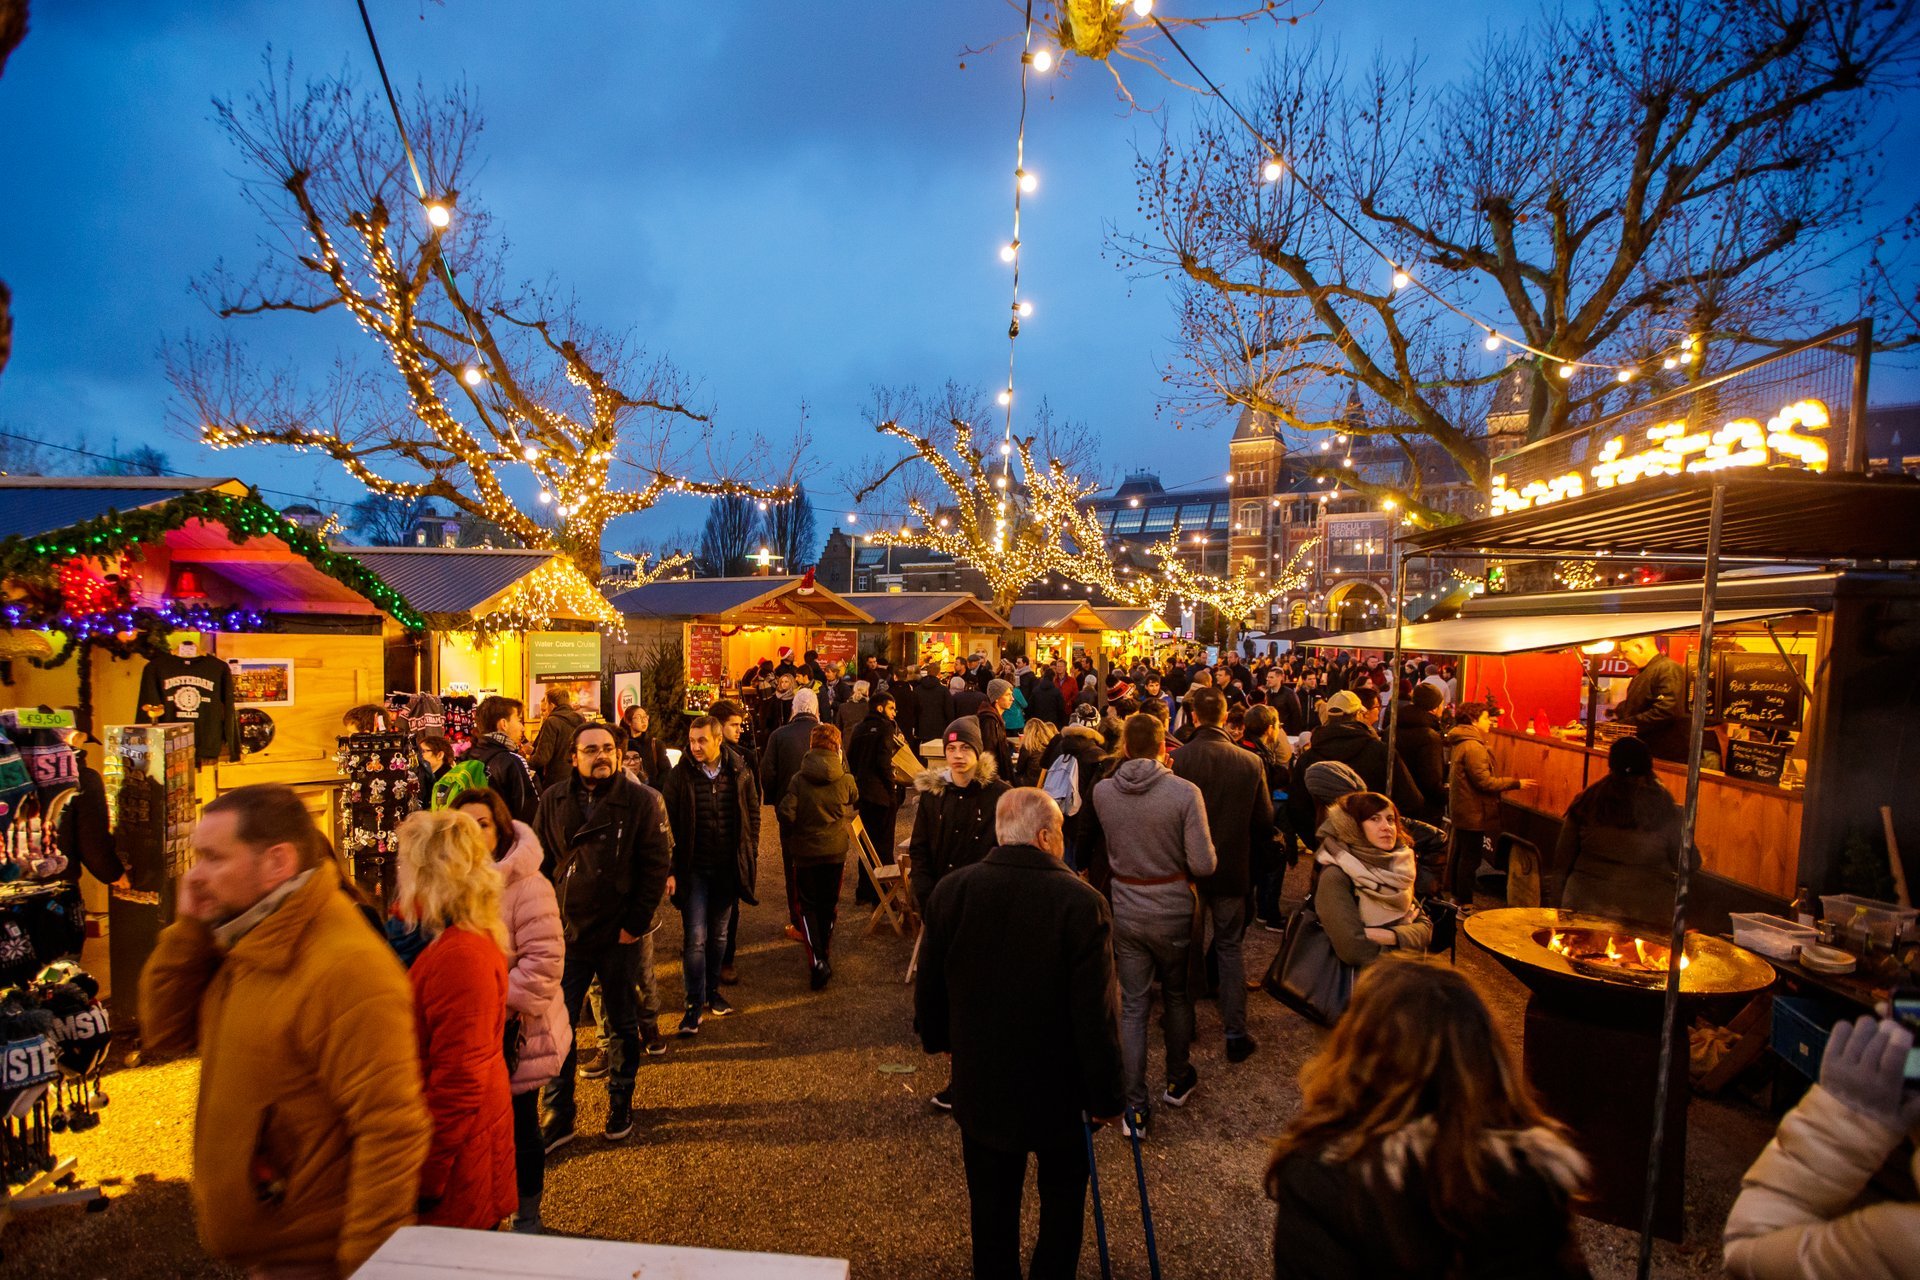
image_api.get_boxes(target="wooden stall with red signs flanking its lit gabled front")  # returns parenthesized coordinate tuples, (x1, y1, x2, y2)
(612, 574, 874, 712)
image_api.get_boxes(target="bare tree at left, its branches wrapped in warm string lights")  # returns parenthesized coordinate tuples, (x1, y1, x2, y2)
(167, 56, 785, 576)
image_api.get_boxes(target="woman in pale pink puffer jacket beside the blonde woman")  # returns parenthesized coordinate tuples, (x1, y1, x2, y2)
(453, 787, 574, 1232)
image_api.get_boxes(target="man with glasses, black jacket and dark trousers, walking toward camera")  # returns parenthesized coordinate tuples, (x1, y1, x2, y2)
(534, 723, 674, 1153)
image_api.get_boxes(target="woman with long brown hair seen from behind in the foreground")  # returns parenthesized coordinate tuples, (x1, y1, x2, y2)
(1267, 963, 1592, 1280)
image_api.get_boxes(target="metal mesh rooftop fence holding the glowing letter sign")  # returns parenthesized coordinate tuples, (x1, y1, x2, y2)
(1492, 320, 1872, 514)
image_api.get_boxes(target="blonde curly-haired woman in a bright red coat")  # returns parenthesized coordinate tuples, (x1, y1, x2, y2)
(396, 810, 516, 1230)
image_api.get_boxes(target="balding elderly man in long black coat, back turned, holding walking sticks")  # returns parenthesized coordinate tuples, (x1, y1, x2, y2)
(914, 787, 1121, 1280)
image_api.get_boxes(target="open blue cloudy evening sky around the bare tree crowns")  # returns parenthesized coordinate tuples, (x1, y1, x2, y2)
(0, 0, 1920, 547)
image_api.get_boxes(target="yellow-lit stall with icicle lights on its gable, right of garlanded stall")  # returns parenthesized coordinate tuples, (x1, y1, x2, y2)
(351, 547, 620, 752)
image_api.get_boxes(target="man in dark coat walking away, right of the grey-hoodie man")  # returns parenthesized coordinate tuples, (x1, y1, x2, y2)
(1173, 689, 1273, 1063)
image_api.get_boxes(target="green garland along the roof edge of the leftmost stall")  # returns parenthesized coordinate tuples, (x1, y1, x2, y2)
(0, 489, 426, 631)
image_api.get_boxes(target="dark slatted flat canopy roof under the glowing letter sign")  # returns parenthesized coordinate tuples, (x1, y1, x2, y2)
(1402, 470, 1920, 562)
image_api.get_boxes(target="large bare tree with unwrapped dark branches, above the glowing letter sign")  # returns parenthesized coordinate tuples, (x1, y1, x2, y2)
(1117, 0, 1920, 514)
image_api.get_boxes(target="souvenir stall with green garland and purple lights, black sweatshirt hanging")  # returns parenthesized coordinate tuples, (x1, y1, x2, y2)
(0, 476, 420, 1023)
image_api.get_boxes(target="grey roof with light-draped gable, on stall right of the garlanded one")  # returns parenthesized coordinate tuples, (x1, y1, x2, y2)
(342, 547, 614, 631)
